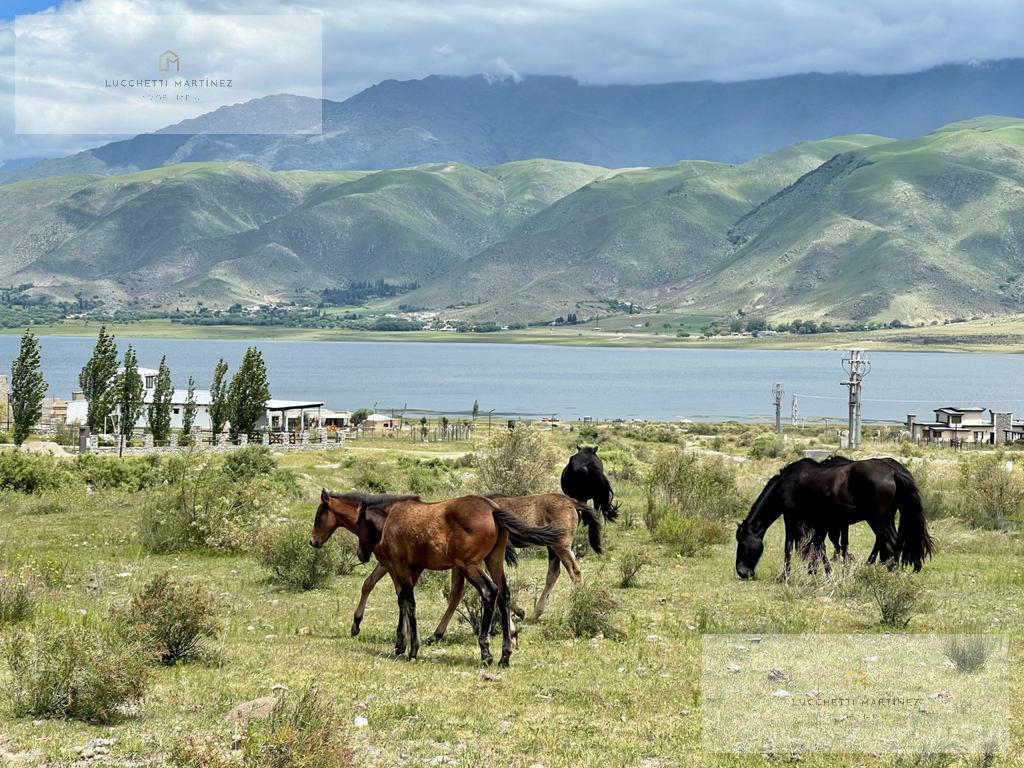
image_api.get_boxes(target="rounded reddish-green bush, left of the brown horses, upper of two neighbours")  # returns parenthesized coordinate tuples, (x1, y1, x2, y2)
(115, 572, 218, 666)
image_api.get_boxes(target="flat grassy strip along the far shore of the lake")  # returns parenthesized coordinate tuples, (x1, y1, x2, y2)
(9, 314, 1024, 353)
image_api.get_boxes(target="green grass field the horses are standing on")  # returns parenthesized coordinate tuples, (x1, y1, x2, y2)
(0, 425, 1024, 768)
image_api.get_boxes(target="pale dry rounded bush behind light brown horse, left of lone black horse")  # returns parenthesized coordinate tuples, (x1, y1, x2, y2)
(478, 424, 555, 496)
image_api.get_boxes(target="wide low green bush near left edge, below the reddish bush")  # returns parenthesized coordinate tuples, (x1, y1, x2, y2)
(0, 621, 148, 723)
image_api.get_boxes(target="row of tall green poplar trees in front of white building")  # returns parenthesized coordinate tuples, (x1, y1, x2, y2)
(78, 327, 270, 454)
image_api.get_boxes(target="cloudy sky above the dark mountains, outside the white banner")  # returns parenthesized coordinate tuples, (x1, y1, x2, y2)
(0, 0, 1024, 160)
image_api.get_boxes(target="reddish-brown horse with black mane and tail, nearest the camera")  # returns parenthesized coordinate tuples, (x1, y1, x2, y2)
(309, 490, 562, 667)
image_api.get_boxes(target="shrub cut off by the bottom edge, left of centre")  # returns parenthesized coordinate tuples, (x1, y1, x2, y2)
(242, 685, 354, 768)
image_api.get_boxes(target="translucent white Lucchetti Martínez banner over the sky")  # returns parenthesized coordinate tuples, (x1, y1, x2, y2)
(14, 12, 324, 134)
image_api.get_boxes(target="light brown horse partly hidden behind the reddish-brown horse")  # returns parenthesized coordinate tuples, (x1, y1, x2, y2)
(351, 494, 601, 643)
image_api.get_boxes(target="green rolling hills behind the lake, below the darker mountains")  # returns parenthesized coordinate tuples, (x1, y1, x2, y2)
(6, 112, 1024, 322)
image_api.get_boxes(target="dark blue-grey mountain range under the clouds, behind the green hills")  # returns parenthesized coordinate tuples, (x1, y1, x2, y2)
(6, 59, 1024, 182)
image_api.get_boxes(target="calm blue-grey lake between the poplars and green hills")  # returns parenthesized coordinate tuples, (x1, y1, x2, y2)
(0, 335, 1024, 422)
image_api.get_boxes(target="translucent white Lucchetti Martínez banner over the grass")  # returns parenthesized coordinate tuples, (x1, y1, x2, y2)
(701, 635, 1010, 754)
